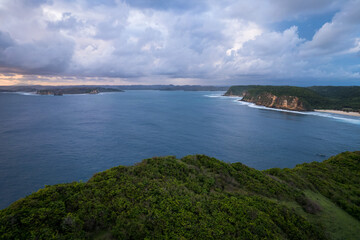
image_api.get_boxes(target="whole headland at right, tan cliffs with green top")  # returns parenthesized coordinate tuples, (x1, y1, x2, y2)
(224, 85, 360, 116)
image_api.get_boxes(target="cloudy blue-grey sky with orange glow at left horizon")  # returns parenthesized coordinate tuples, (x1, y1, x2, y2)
(0, 0, 360, 85)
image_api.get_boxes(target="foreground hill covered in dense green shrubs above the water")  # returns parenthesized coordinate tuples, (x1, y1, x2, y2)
(0, 152, 360, 239)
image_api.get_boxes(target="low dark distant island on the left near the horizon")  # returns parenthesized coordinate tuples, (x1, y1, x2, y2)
(36, 87, 123, 96)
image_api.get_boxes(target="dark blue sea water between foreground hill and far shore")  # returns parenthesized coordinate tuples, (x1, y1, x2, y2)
(0, 91, 360, 208)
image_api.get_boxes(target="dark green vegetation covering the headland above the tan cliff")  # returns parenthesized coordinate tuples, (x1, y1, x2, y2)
(225, 85, 360, 111)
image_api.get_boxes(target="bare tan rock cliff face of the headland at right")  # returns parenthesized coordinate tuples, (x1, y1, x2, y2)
(242, 93, 312, 111)
